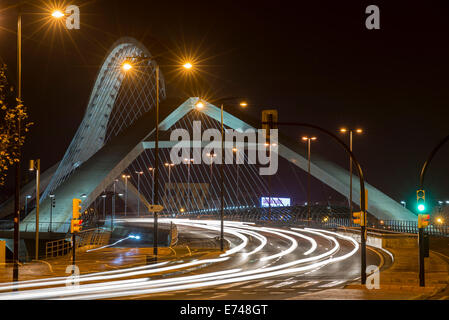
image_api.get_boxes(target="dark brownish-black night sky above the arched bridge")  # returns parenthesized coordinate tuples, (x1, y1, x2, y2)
(0, 0, 449, 206)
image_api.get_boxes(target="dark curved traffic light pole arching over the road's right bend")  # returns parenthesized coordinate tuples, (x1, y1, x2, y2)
(262, 122, 367, 285)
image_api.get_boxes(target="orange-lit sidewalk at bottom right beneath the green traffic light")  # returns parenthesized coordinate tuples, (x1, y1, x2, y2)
(293, 249, 449, 300)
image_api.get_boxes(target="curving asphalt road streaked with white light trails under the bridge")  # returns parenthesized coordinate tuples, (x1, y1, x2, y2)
(0, 218, 391, 300)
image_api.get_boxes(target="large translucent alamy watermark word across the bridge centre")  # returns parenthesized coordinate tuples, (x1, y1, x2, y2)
(170, 121, 279, 176)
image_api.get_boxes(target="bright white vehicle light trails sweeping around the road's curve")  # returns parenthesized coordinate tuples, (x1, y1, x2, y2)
(0, 219, 359, 300)
